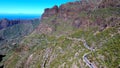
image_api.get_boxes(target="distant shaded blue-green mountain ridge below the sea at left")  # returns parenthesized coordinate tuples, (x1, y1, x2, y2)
(0, 19, 40, 54)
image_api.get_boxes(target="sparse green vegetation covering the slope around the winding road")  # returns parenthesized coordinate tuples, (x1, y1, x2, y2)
(1, 0, 120, 68)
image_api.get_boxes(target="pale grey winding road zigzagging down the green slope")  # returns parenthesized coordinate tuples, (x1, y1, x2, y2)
(67, 37, 97, 68)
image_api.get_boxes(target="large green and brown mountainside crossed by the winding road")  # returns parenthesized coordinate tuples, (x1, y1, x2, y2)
(0, 0, 120, 68)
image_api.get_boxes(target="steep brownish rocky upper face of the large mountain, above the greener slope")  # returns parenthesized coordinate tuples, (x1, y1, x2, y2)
(35, 0, 120, 34)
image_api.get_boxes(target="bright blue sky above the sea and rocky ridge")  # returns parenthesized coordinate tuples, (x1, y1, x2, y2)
(0, 0, 73, 14)
